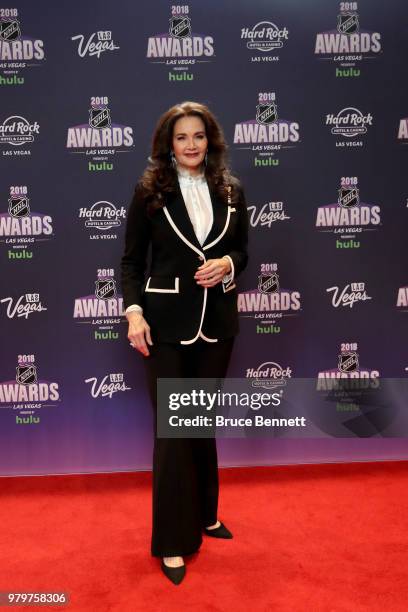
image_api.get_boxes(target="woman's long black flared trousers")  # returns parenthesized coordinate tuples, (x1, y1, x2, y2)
(143, 337, 234, 557)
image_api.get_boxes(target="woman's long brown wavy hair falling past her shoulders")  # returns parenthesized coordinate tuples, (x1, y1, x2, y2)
(140, 102, 238, 212)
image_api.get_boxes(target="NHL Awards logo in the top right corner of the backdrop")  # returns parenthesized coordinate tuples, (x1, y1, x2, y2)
(315, 2, 381, 78)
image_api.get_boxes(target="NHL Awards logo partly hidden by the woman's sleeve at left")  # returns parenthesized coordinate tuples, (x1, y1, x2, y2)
(73, 268, 124, 340)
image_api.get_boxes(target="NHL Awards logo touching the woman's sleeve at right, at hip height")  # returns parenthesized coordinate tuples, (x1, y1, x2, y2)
(238, 263, 301, 334)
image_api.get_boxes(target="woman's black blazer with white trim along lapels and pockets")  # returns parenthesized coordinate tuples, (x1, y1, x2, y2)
(121, 178, 248, 344)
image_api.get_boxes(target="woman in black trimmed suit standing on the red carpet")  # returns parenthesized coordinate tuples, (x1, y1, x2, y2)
(121, 102, 248, 584)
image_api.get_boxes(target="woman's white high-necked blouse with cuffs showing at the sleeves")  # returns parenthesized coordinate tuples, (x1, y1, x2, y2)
(125, 168, 234, 313)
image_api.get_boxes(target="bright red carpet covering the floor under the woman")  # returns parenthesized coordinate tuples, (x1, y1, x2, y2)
(0, 462, 408, 612)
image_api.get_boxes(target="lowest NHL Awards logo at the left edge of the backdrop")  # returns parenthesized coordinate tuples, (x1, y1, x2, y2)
(0, 355, 60, 425)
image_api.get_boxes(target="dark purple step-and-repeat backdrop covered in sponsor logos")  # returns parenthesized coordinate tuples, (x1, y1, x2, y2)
(0, 0, 408, 475)
